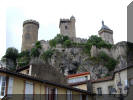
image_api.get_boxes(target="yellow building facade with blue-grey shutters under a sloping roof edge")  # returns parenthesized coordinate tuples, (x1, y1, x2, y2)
(0, 68, 92, 100)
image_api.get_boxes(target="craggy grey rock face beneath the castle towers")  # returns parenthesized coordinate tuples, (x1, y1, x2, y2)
(40, 42, 130, 79)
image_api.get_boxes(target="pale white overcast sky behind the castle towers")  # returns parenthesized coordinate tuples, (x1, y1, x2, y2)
(0, 0, 132, 58)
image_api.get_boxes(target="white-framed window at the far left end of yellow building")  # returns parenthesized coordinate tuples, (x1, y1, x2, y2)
(0, 76, 6, 98)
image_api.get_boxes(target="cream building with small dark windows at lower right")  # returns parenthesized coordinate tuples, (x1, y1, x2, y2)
(92, 68, 128, 94)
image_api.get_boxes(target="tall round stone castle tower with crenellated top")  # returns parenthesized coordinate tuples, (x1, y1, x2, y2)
(21, 20, 39, 51)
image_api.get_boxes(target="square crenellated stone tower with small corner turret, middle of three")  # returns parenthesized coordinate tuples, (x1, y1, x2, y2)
(59, 16, 76, 38)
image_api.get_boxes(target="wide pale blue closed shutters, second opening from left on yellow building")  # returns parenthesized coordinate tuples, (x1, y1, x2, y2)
(25, 82, 33, 100)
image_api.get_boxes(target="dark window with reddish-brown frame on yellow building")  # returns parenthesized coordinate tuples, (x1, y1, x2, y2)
(46, 87, 58, 100)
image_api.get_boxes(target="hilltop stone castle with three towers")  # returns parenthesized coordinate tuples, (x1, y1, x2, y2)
(21, 16, 114, 51)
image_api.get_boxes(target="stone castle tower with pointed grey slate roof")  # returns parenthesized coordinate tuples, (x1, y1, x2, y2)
(98, 21, 114, 44)
